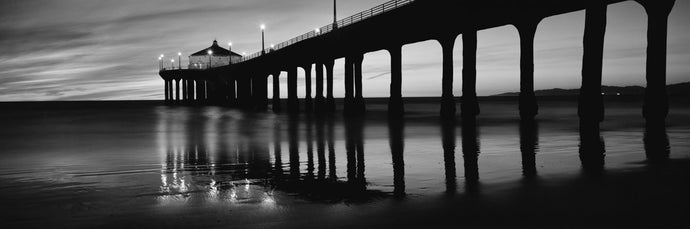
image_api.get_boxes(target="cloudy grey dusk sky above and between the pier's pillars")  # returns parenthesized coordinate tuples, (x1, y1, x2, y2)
(0, 0, 690, 101)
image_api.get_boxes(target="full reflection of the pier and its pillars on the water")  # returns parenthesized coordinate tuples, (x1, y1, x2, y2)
(157, 108, 670, 206)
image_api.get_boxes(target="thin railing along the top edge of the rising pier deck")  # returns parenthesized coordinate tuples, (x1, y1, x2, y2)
(238, 0, 415, 63)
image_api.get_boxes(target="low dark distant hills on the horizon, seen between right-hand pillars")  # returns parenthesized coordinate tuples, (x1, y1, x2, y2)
(492, 82, 690, 96)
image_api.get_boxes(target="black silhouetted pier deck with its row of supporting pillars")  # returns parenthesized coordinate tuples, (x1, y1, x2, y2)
(160, 0, 675, 123)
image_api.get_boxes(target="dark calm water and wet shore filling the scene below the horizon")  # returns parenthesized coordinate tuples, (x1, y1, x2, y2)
(0, 97, 690, 228)
